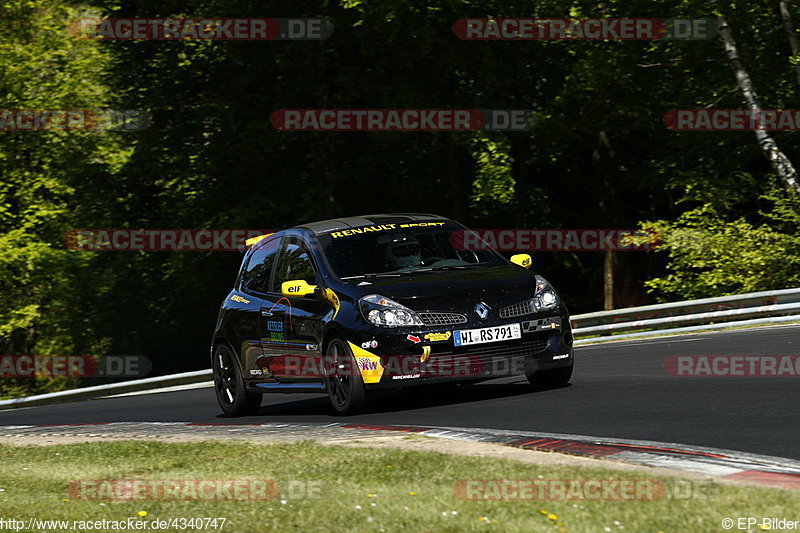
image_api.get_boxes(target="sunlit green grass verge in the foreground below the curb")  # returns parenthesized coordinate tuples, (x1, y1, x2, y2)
(0, 438, 800, 533)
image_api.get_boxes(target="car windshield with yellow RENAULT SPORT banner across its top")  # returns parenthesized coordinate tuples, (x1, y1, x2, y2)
(319, 222, 508, 279)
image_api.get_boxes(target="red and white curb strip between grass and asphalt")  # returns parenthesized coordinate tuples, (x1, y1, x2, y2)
(0, 422, 800, 490)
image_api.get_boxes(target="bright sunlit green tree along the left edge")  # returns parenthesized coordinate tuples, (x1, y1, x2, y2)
(0, 0, 124, 395)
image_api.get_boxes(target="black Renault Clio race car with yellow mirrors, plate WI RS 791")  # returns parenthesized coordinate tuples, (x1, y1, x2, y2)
(211, 214, 574, 416)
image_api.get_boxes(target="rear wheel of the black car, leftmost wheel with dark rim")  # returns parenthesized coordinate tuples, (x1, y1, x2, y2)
(211, 344, 262, 417)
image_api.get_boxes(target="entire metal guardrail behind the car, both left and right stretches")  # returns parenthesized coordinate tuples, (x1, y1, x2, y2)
(0, 288, 800, 410)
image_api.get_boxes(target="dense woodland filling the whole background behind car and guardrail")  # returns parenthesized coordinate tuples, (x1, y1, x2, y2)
(0, 0, 800, 393)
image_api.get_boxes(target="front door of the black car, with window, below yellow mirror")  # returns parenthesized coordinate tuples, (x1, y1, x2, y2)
(270, 237, 331, 380)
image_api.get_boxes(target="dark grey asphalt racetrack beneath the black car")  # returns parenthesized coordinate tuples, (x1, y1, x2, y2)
(0, 325, 800, 459)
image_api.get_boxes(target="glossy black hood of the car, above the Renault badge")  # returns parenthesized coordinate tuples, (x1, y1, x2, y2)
(338, 265, 536, 313)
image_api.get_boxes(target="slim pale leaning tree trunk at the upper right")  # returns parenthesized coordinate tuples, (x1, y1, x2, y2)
(709, 0, 800, 193)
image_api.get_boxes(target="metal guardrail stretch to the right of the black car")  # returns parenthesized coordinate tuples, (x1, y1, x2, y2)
(571, 288, 800, 337)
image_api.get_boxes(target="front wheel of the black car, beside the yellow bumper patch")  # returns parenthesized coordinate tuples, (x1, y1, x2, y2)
(325, 338, 367, 415)
